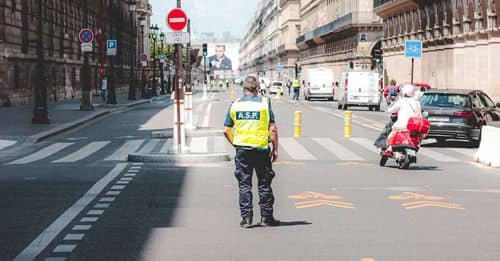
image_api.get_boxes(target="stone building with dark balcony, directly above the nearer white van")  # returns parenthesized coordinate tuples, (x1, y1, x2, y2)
(296, 0, 382, 81)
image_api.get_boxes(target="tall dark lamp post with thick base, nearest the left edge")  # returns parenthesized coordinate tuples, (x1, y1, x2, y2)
(31, 0, 50, 124)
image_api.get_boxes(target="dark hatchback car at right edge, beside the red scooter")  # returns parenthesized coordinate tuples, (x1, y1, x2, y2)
(420, 89, 500, 143)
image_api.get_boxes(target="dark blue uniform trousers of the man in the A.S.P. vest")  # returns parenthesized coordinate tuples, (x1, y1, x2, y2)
(234, 148, 275, 218)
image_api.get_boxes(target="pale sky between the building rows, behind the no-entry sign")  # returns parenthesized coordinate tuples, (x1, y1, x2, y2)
(150, 0, 259, 36)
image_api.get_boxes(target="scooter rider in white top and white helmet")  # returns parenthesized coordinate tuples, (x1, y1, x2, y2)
(387, 83, 422, 151)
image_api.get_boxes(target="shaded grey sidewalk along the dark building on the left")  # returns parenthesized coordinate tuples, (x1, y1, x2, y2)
(0, 93, 167, 150)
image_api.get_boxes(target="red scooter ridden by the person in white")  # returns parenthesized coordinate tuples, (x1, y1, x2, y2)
(380, 115, 430, 169)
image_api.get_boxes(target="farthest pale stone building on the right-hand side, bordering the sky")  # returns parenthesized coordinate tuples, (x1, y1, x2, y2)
(240, 0, 300, 81)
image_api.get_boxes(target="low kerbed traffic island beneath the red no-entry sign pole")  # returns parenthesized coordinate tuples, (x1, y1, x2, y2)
(128, 150, 231, 164)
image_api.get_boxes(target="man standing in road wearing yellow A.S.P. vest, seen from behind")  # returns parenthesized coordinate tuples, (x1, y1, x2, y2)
(224, 76, 280, 228)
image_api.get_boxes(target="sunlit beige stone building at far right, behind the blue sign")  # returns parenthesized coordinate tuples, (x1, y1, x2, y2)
(374, 0, 500, 100)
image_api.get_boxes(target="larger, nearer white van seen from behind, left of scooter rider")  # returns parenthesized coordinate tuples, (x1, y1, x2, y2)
(335, 71, 381, 111)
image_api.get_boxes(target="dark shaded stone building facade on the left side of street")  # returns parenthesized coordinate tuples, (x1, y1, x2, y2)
(0, 0, 147, 106)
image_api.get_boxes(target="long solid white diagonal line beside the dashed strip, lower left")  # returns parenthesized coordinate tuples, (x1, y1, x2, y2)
(14, 163, 127, 261)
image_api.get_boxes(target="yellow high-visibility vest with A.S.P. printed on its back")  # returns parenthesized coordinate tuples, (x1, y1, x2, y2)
(230, 97, 270, 149)
